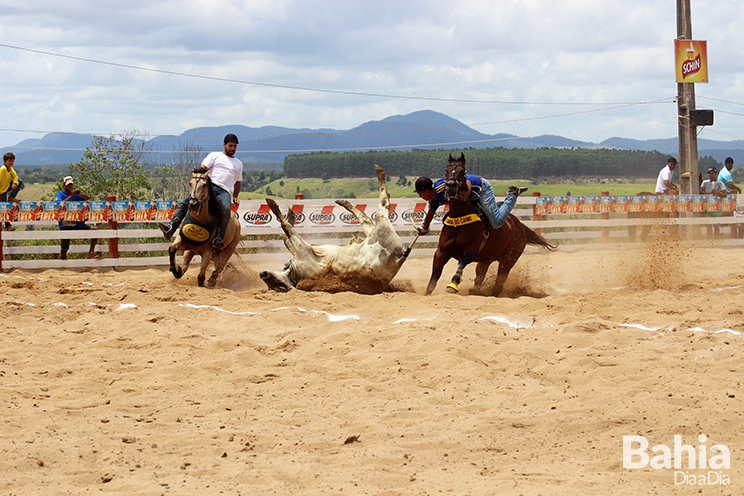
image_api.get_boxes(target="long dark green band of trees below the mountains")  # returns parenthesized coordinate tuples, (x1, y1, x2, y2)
(284, 147, 720, 180)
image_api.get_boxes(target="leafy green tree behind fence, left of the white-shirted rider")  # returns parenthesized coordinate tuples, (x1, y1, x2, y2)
(69, 131, 152, 200)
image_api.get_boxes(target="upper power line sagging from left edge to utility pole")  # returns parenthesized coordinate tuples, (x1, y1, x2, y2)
(0, 43, 676, 105)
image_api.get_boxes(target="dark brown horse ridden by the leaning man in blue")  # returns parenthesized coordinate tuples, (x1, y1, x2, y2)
(426, 161, 556, 296)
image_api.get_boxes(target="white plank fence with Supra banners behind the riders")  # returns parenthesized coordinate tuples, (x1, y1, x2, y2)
(0, 197, 744, 270)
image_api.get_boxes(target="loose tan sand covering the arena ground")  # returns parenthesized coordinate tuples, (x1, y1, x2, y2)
(0, 238, 744, 495)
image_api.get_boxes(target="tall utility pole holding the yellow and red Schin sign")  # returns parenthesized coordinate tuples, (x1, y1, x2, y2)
(677, 0, 700, 195)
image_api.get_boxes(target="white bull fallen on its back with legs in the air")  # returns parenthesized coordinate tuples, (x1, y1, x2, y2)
(260, 165, 413, 293)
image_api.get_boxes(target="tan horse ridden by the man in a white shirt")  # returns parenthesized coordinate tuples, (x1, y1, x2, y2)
(168, 169, 240, 287)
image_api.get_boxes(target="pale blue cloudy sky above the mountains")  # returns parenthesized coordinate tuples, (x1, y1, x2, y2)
(0, 0, 744, 146)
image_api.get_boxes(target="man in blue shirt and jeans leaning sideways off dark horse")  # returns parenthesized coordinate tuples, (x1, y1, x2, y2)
(414, 174, 527, 235)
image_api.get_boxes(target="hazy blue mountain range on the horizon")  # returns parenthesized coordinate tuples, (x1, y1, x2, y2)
(0, 110, 744, 166)
